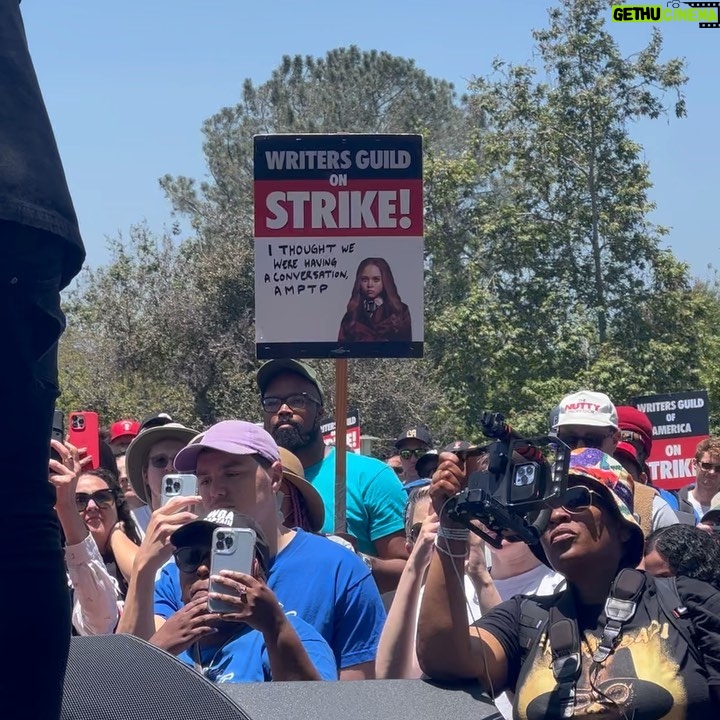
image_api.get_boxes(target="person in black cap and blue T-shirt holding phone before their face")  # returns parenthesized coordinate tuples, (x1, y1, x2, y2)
(150, 510, 338, 683)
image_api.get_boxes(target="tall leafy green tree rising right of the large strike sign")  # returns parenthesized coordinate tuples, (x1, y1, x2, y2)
(434, 0, 697, 430)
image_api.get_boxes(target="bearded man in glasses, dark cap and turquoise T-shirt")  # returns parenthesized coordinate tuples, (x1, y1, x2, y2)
(257, 359, 407, 592)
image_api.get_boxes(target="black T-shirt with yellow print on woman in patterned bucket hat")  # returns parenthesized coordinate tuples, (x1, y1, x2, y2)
(477, 578, 720, 720)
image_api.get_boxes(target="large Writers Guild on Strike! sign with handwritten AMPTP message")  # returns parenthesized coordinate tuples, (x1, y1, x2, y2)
(254, 135, 424, 359)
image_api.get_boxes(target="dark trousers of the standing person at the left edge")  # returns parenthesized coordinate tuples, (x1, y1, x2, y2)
(0, 222, 71, 720)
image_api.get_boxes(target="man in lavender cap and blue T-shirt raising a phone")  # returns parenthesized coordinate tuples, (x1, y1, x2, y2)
(145, 420, 385, 680)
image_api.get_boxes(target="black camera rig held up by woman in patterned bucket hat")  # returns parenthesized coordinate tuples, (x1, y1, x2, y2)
(446, 412, 570, 548)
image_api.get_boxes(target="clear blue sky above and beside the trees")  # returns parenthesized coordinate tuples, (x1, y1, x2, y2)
(21, 0, 720, 277)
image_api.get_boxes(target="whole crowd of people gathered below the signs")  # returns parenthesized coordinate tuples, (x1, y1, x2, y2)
(50, 374, 720, 718)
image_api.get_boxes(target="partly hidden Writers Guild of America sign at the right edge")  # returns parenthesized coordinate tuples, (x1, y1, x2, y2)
(632, 390, 710, 490)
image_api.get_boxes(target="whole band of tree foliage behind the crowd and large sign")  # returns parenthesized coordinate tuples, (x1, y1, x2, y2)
(61, 0, 720, 452)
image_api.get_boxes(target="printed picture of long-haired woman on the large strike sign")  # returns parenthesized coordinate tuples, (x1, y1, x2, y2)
(338, 258, 412, 342)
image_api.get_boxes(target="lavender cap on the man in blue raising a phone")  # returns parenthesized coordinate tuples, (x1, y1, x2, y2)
(175, 420, 280, 472)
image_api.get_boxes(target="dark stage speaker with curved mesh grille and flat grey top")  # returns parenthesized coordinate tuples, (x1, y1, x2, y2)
(60, 635, 502, 720)
